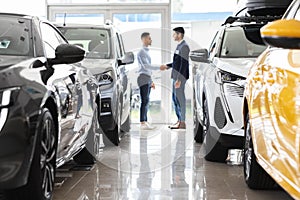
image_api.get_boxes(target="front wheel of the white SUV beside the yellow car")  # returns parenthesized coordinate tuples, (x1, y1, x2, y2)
(203, 99, 228, 162)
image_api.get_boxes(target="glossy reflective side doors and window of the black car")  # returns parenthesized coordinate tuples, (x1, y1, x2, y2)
(40, 23, 94, 160)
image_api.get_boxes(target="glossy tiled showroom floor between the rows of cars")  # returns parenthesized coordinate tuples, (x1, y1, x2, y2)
(53, 122, 291, 200)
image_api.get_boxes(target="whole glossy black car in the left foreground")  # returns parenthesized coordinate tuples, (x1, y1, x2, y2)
(0, 13, 100, 200)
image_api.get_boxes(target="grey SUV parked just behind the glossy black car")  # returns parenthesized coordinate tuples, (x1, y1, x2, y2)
(56, 23, 134, 145)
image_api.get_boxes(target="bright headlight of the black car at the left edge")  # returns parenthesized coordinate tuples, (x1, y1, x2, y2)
(0, 87, 20, 131)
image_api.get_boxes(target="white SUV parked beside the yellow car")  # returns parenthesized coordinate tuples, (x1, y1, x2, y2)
(191, 16, 277, 162)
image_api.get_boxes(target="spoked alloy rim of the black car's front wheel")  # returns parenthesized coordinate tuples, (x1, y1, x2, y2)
(41, 119, 55, 199)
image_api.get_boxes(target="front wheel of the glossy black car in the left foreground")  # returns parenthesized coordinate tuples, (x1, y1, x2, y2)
(5, 108, 57, 200)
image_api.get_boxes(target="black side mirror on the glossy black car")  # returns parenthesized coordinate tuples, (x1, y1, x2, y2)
(48, 44, 85, 65)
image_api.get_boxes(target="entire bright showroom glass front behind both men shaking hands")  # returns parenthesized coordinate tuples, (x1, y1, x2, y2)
(47, 0, 237, 123)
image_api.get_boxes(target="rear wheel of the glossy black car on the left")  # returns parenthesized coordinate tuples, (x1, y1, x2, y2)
(73, 108, 100, 165)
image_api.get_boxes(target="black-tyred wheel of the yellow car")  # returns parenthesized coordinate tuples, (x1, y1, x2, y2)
(244, 114, 277, 189)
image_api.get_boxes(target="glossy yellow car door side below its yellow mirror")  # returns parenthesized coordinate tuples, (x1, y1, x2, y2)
(263, 48, 300, 184)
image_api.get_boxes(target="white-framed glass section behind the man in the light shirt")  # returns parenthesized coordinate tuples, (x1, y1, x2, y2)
(47, 0, 175, 123)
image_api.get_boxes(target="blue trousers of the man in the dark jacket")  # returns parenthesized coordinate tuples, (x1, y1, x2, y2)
(172, 80, 186, 121)
